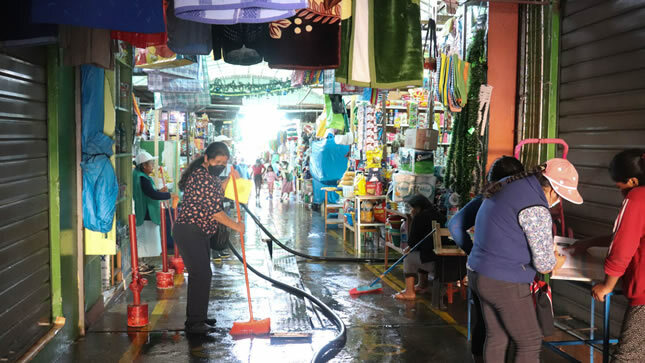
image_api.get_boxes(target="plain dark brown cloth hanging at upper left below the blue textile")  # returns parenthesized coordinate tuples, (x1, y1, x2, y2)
(60, 25, 114, 69)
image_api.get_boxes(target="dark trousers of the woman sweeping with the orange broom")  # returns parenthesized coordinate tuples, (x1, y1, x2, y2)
(173, 224, 213, 325)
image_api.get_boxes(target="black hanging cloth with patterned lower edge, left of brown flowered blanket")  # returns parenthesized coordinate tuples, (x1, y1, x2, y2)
(212, 24, 269, 66)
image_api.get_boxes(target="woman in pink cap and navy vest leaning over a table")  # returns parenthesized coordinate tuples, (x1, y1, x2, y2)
(467, 159, 582, 363)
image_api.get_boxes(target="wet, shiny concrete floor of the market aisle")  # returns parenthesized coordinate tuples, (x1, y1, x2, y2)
(45, 192, 604, 363)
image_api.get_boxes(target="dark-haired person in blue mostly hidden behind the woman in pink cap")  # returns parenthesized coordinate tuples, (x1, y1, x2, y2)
(447, 156, 524, 363)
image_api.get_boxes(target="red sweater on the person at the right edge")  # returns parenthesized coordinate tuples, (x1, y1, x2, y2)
(605, 186, 645, 306)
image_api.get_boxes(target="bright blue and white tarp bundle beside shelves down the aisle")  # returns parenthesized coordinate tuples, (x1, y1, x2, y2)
(309, 135, 349, 182)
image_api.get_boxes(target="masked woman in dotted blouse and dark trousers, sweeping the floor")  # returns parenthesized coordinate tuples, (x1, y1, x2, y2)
(173, 142, 244, 334)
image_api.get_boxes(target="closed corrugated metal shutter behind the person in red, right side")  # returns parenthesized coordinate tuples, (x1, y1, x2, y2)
(558, 0, 645, 236)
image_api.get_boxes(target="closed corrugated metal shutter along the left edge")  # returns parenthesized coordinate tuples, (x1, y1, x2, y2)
(0, 54, 51, 361)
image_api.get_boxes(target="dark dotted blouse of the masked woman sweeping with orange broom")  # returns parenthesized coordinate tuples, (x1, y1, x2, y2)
(177, 166, 224, 235)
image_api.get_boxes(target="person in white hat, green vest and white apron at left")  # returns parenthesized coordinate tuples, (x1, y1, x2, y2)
(132, 151, 171, 273)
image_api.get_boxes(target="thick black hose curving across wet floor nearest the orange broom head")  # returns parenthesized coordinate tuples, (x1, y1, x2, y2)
(228, 240, 347, 363)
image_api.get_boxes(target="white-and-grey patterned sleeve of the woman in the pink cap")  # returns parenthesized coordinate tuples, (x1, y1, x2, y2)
(518, 206, 556, 273)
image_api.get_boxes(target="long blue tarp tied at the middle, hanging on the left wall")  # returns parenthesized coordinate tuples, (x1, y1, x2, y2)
(81, 65, 119, 233)
